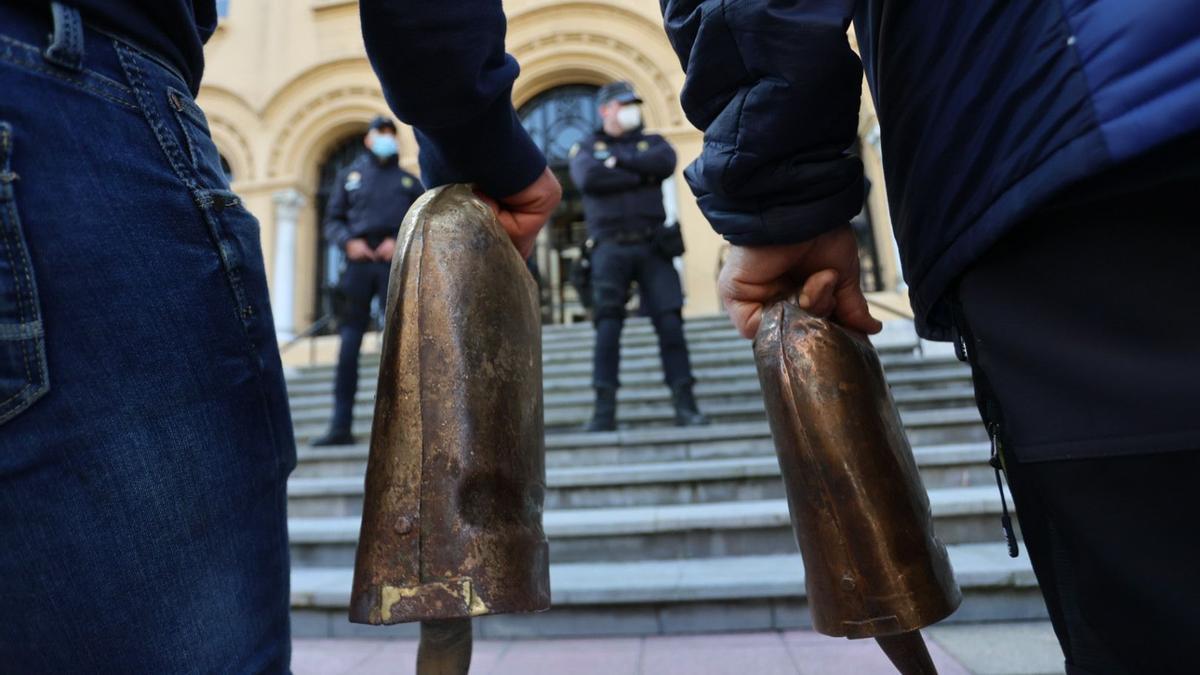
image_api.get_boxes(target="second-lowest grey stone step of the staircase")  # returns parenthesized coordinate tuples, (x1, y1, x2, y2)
(288, 485, 1002, 567)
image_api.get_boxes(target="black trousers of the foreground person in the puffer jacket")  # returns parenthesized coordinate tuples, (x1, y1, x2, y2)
(958, 178, 1200, 675)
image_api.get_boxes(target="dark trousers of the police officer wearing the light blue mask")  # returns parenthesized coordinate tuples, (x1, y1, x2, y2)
(330, 262, 391, 431)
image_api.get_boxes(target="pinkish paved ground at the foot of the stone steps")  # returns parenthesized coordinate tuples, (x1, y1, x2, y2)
(292, 622, 1063, 675)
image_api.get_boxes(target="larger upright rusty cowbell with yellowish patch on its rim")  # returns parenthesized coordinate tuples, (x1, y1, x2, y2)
(350, 185, 550, 623)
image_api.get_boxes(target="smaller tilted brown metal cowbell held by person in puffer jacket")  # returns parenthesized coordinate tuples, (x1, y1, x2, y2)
(754, 301, 961, 638)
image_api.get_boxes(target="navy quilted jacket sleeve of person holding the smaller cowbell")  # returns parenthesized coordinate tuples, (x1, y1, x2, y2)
(660, 0, 863, 246)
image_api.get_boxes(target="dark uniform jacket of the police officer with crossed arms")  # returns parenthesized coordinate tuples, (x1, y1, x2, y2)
(571, 130, 676, 240)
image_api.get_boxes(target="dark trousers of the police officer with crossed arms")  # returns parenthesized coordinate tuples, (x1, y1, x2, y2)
(592, 241, 692, 388)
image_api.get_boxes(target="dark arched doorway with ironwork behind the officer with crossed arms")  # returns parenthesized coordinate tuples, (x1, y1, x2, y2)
(518, 84, 600, 323)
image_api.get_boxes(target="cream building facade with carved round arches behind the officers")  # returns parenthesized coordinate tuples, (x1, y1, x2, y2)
(199, 0, 901, 340)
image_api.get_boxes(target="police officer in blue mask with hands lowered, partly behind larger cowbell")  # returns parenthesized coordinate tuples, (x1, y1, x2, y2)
(313, 117, 424, 446)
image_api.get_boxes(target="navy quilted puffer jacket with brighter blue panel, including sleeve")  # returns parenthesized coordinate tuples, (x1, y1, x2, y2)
(661, 0, 1200, 339)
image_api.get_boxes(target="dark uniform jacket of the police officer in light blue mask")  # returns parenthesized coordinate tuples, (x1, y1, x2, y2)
(325, 153, 425, 247)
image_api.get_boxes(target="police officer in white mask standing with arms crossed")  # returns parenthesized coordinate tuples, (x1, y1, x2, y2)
(571, 82, 708, 431)
